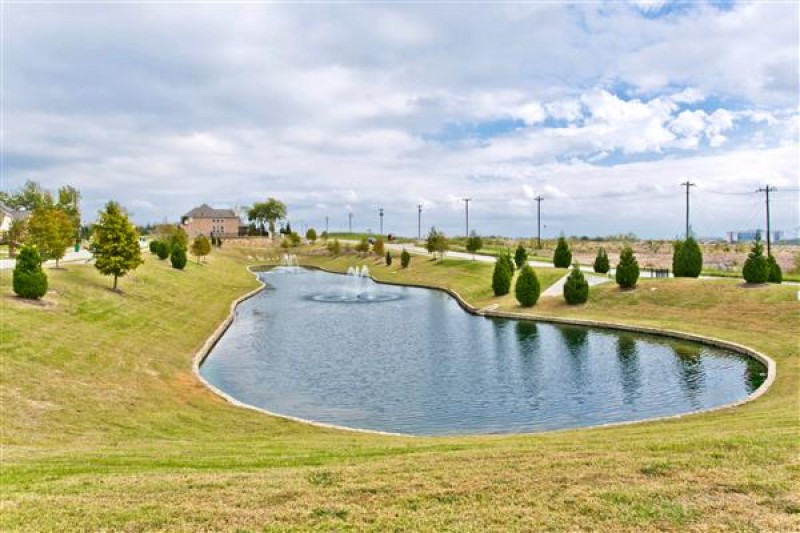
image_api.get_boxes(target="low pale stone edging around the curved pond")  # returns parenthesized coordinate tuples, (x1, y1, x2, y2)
(193, 265, 777, 438)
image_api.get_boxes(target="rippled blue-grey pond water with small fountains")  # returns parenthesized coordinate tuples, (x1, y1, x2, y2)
(200, 268, 766, 435)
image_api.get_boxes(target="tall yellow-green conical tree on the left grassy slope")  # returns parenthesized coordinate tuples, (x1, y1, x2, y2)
(91, 201, 142, 290)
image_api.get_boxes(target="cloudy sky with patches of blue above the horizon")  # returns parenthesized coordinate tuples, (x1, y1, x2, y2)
(0, 1, 800, 238)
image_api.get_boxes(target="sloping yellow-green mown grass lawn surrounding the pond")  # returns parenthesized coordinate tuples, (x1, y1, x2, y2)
(0, 242, 800, 531)
